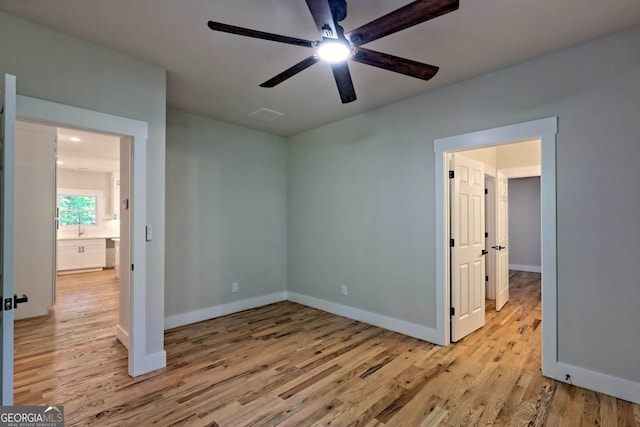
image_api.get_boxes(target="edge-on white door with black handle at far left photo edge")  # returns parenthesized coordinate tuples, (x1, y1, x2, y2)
(0, 74, 16, 406)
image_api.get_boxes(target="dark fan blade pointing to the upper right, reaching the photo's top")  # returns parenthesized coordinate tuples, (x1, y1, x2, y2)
(345, 0, 459, 46)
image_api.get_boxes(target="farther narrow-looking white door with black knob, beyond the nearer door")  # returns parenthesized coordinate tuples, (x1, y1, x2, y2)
(492, 171, 509, 311)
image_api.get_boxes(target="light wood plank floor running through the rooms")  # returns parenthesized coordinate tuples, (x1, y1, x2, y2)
(15, 271, 640, 427)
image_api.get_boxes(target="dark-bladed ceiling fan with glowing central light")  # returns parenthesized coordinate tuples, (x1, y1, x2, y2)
(208, 0, 459, 104)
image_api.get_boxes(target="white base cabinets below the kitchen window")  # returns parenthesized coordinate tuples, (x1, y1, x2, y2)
(58, 239, 107, 271)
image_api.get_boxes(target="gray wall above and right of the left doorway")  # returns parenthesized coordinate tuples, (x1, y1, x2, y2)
(0, 13, 166, 355)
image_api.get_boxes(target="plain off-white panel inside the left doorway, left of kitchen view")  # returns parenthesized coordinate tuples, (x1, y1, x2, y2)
(14, 121, 56, 320)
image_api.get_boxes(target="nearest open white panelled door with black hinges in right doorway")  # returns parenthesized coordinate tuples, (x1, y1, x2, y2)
(451, 154, 486, 342)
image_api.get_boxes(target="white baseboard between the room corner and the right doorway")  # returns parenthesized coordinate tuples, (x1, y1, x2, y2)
(287, 292, 440, 343)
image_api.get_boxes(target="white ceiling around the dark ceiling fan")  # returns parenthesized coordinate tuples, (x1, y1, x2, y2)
(0, 0, 640, 135)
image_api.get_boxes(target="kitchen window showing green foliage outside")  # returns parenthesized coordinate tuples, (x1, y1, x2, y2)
(58, 188, 102, 226)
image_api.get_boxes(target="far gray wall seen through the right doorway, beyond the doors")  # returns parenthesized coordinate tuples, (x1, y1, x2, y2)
(509, 176, 542, 268)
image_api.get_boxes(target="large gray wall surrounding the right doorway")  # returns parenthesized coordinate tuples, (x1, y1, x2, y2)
(288, 28, 640, 382)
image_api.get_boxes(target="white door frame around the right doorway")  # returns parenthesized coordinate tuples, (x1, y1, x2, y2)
(433, 117, 558, 378)
